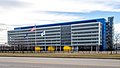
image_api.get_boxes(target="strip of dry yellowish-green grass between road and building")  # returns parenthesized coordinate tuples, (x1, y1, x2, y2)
(0, 53, 120, 59)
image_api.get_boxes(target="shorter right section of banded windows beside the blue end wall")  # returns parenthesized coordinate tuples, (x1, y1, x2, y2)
(71, 22, 102, 46)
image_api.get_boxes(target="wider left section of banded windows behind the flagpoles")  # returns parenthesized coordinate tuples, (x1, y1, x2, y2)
(8, 26, 61, 46)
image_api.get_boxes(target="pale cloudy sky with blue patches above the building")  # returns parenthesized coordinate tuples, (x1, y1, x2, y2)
(0, 0, 120, 42)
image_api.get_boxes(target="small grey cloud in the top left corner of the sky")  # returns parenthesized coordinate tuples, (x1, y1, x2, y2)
(0, 0, 27, 7)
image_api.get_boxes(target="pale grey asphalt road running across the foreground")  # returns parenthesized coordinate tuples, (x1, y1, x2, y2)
(0, 57, 120, 68)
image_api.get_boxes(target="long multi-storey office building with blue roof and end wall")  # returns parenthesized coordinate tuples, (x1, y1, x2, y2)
(8, 18, 113, 51)
